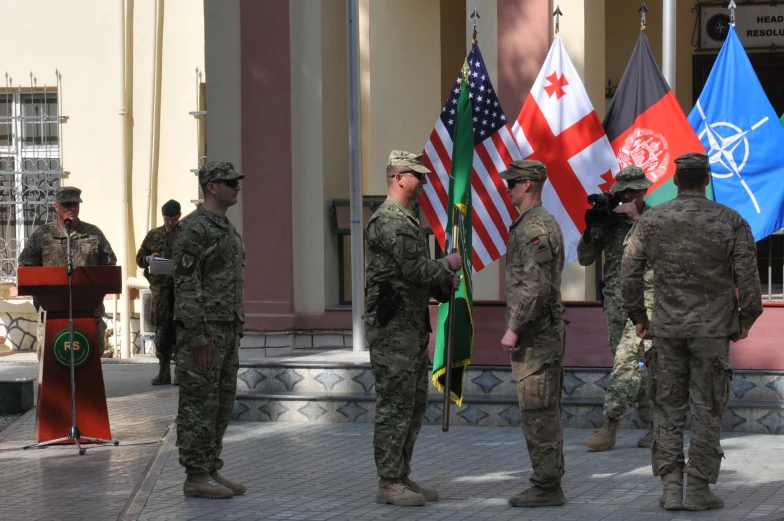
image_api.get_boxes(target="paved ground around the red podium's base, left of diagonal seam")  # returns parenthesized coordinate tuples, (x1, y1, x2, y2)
(0, 386, 178, 521)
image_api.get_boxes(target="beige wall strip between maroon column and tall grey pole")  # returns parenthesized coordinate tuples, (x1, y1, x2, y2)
(290, 0, 350, 313)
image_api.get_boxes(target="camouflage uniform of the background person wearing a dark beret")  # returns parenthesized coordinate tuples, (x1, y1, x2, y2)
(136, 226, 174, 363)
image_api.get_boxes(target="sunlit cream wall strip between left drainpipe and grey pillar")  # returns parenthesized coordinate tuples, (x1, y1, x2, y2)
(130, 0, 206, 273)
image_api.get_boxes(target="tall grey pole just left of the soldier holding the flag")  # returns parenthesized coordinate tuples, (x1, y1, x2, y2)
(346, 0, 365, 352)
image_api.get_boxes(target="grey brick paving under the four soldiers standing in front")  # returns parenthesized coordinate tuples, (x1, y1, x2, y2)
(138, 422, 784, 521)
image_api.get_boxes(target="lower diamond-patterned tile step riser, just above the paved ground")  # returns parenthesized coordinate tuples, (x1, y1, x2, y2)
(234, 391, 784, 434)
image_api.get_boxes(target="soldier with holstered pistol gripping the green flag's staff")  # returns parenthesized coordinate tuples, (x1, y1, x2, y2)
(364, 150, 462, 506)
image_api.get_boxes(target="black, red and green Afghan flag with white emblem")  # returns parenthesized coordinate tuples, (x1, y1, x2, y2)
(603, 31, 705, 205)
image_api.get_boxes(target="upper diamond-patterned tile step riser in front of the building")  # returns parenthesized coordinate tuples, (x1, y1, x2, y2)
(237, 361, 784, 402)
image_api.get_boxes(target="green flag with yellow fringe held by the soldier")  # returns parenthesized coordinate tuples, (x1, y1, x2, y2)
(432, 73, 474, 406)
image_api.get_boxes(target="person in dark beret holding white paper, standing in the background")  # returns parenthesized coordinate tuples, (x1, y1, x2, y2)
(136, 199, 182, 385)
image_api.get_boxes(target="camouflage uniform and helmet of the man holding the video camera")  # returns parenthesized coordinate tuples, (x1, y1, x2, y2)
(577, 166, 653, 428)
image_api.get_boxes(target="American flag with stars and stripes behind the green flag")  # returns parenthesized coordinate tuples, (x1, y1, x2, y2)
(421, 43, 522, 272)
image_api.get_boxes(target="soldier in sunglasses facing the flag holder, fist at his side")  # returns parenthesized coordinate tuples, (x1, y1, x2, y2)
(501, 159, 566, 507)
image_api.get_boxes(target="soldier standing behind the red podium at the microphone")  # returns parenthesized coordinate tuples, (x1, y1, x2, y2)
(18, 186, 117, 360)
